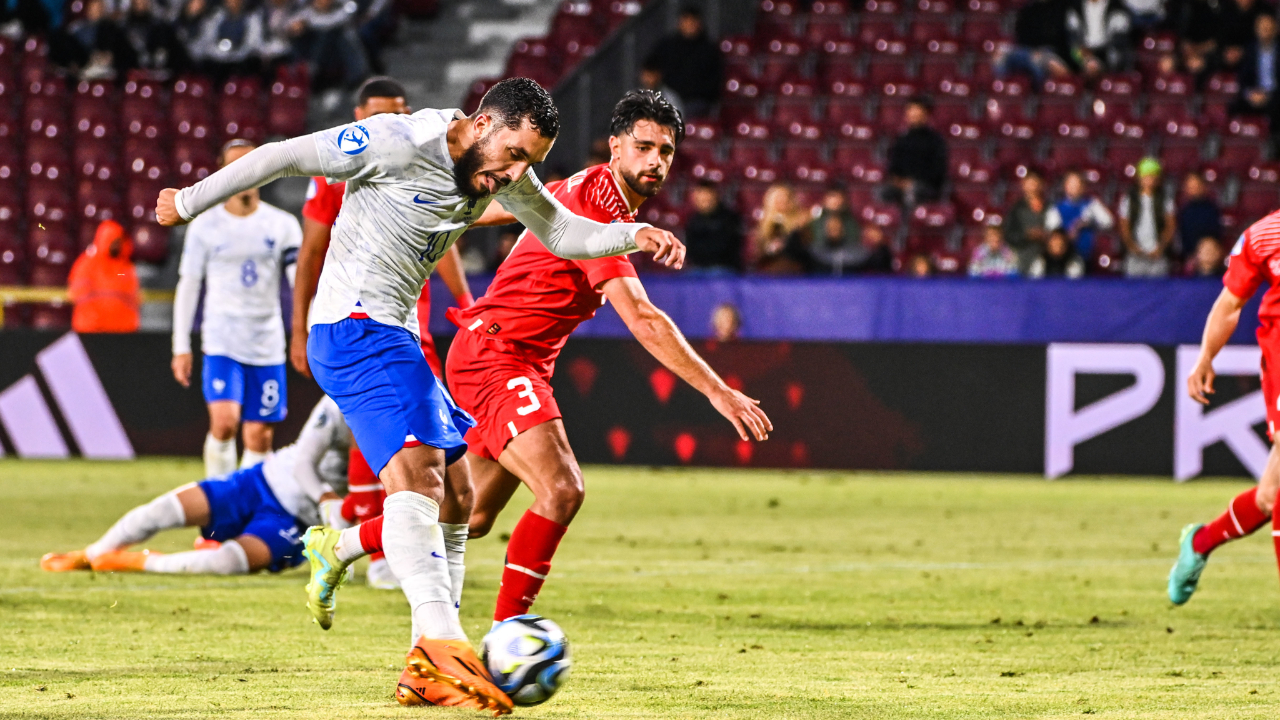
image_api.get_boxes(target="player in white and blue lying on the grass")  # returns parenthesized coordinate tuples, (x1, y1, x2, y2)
(40, 397, 351, 575)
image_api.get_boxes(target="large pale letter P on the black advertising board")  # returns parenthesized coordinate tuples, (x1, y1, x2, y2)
(1044, 343, 1165, 478)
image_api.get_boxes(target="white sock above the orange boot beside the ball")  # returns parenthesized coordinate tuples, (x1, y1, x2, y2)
(383, 491, 467, 641)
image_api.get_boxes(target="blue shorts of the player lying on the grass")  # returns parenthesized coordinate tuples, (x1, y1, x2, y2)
(198, 464, 306, 573)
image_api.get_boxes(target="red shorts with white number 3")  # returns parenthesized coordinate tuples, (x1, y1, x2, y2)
(444, 329, 561, 460)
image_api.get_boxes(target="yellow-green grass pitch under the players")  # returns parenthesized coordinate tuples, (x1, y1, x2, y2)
(0, 460, 1280, 719)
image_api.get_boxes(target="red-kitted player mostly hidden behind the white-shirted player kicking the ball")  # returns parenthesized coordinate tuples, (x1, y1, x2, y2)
(289, 77, 475, 589)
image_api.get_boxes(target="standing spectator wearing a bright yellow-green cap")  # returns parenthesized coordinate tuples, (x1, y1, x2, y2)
(1119, 158, 1178, 278)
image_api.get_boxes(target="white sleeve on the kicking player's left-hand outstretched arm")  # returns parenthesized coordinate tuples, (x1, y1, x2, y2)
(174, 135, 323, 220)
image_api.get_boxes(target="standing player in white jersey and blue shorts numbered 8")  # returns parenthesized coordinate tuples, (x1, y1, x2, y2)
(173, 140, 302, 478)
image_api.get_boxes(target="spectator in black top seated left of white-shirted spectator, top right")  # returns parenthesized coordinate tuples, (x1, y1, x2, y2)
(993, 0, 1071, 87)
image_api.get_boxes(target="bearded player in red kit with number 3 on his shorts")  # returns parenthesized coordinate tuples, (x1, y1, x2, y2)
(312, 91, 773, 623)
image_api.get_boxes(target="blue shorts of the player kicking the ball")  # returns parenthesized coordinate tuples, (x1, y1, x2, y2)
(307, 318, 476, 475)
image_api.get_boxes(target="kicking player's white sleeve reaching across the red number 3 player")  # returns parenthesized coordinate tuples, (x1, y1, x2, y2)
(497, 170, 650, 260)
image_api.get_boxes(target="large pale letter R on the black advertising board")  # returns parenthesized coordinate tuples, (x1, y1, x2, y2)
(1174, 345, 1270, 482)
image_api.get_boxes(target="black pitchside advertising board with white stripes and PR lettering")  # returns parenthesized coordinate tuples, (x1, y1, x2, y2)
(0, 332, 1266, 479)
